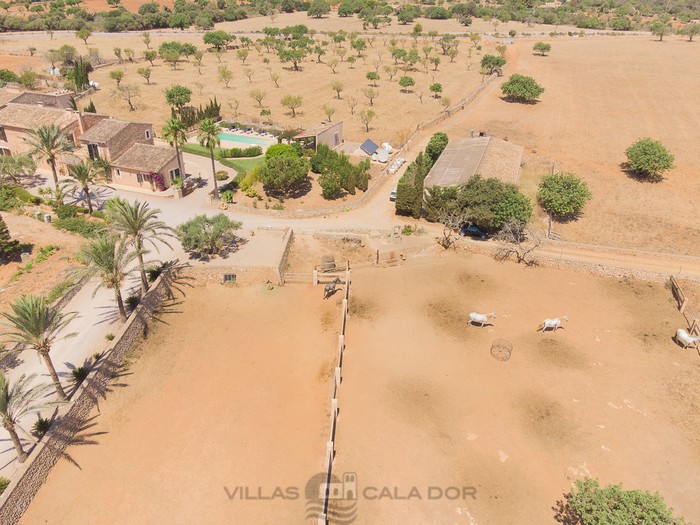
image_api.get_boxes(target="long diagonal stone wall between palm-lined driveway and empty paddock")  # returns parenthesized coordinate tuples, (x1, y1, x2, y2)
(0, 277, 170, 525)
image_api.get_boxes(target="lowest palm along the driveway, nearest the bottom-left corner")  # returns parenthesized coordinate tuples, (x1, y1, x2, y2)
(0, 370, 46, 463)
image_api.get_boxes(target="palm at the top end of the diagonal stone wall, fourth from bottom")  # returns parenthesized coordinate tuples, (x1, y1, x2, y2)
(107, 198, 174, 295)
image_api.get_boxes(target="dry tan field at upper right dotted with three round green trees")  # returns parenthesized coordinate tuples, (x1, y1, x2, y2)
(444, 33, 700, 255)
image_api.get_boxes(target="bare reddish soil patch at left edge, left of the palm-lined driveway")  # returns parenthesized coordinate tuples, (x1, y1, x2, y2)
(0, 212, 84, 311)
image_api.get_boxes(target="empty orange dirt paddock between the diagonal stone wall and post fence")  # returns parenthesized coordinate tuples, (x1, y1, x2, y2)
(22, 285, 339, 525)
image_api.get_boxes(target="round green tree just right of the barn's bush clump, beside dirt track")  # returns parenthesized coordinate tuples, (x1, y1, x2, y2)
(537, 173, 591, 220)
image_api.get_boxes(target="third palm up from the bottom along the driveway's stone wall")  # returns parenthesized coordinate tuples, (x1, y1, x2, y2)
(78, 235, 137, 323)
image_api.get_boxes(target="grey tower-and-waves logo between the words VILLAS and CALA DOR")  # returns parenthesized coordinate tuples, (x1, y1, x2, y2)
(304, 472, 357, 525)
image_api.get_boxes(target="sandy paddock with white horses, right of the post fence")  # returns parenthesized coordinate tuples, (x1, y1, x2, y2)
(334, 255, 700, 525)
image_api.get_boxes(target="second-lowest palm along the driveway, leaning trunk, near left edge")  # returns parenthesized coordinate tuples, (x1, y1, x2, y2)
(0, 295, 78, 401)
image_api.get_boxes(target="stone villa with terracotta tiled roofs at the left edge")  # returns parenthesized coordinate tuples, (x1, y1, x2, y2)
(0, 89, 180, 191)
